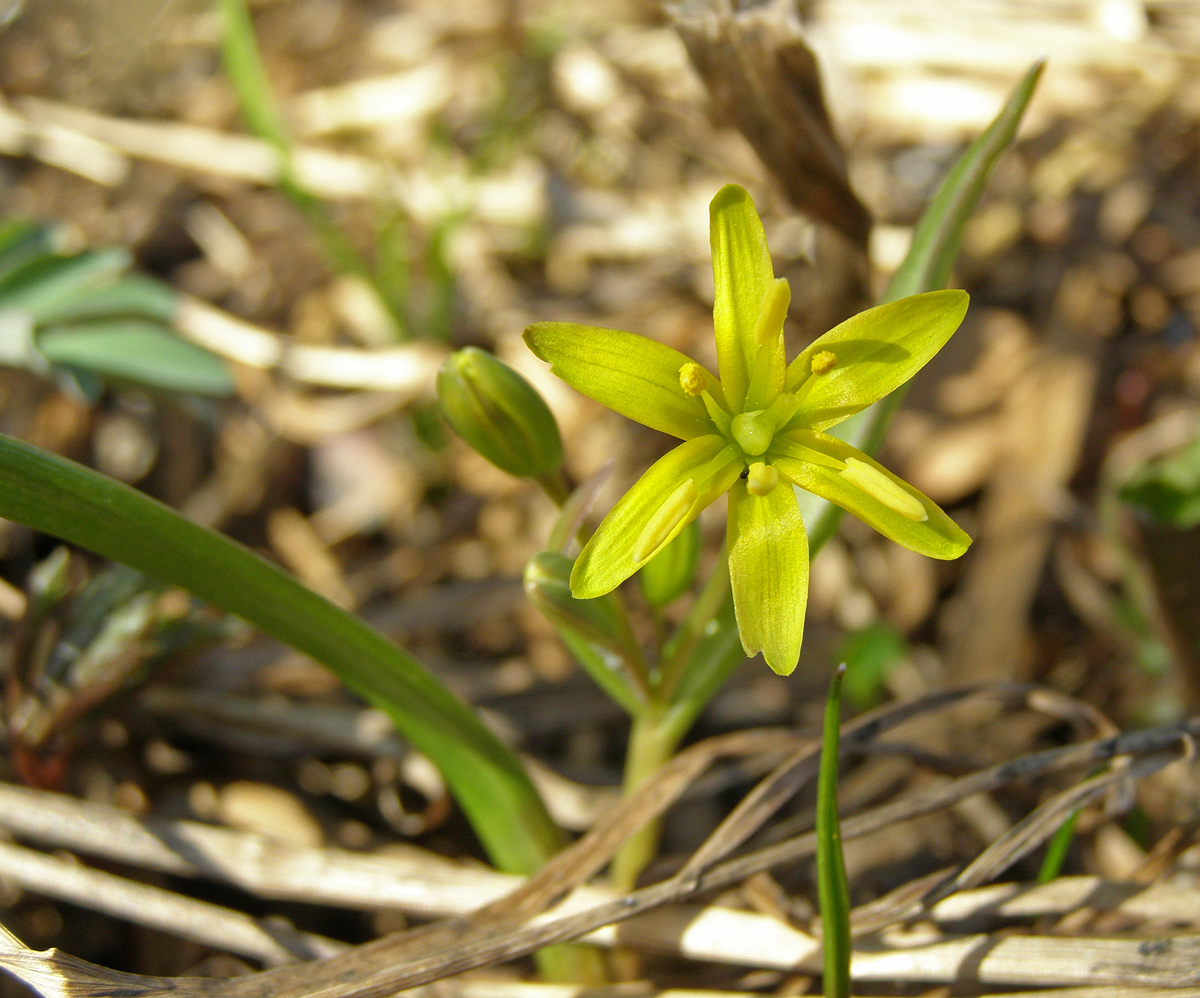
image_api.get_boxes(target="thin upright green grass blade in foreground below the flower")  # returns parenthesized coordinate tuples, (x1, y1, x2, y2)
(817, 663, 850, 998)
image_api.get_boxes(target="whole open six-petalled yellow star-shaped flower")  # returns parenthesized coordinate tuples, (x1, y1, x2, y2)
(524, 185, 971, 675)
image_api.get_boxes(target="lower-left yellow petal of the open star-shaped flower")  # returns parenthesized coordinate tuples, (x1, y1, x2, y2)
(571, 433, 744, 600)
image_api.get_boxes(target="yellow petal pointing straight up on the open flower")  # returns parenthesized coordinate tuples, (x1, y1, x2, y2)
(708, 184, 775, 411)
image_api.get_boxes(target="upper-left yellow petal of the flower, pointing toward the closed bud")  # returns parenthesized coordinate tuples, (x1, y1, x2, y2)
(524, 323, 720, 440)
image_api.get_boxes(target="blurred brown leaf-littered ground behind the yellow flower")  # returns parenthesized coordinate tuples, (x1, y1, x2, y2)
(0, 0, 1200, 986)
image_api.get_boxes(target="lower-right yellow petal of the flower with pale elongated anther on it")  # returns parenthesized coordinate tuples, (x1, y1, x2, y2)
(770, 429, 971, 560)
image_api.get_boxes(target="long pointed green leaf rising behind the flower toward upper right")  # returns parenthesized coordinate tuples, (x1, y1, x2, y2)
(798, 60, 1043, 557)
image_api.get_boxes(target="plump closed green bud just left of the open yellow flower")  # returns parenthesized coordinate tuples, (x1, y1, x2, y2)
(438, 347, 563, 479)
